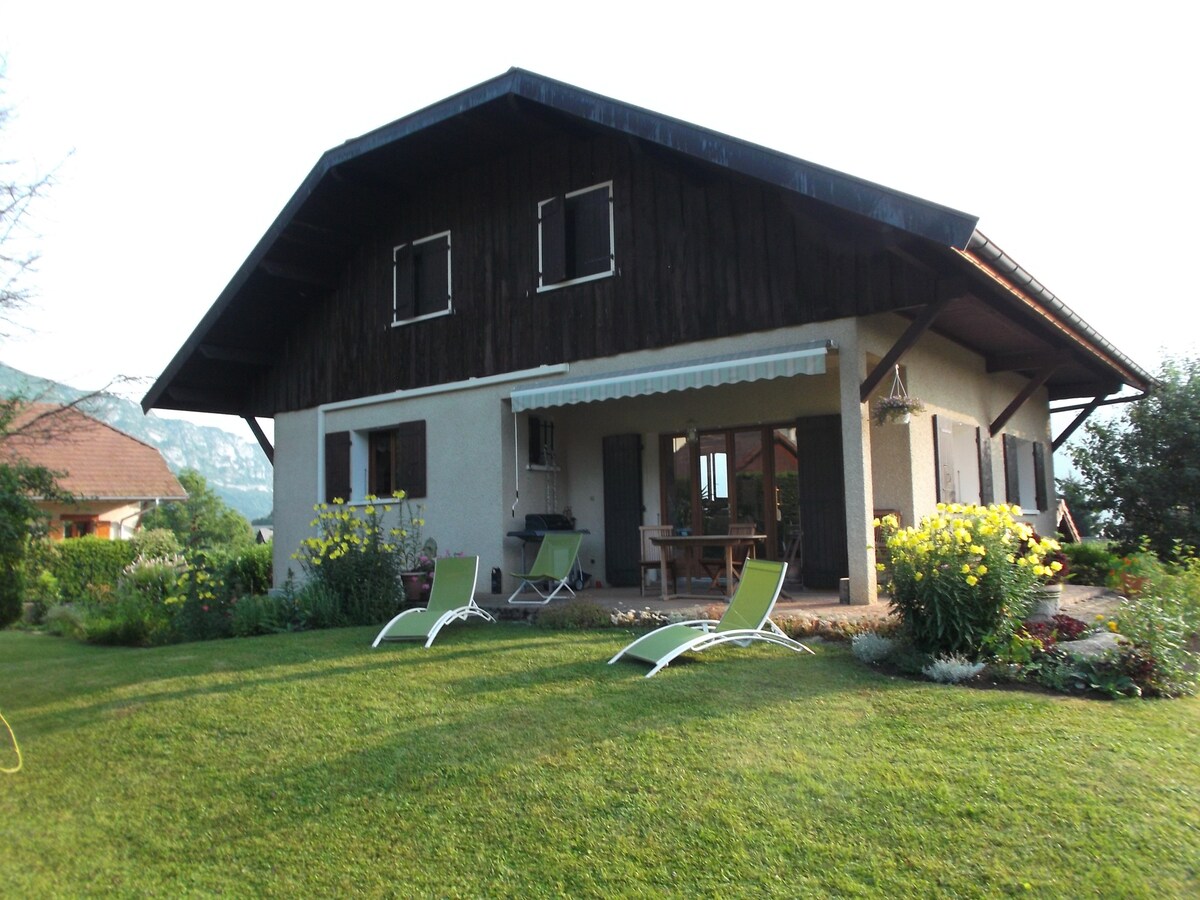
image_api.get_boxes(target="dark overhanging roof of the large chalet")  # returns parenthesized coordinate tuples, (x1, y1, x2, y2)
(142, 68, 1153, 416)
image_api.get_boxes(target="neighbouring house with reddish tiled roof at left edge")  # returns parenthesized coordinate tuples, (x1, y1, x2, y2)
(2, 403, 187, 540)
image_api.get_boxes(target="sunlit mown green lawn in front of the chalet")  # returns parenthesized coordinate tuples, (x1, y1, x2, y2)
(0, 624, 1200, 898)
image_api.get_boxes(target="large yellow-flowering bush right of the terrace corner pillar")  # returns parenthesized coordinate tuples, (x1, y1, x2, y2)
(878, 504, 1061, 659)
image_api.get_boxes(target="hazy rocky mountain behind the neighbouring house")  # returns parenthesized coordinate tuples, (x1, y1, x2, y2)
(0, 362, 272, 521)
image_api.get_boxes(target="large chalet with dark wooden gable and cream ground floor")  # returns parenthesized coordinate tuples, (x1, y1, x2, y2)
(143, 70, 1151, 602)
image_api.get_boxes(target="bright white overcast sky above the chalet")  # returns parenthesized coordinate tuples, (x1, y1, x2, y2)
(0, 0, 1200, 444)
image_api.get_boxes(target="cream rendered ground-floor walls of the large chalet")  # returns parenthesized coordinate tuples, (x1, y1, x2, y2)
(275, 314, 1055, 602)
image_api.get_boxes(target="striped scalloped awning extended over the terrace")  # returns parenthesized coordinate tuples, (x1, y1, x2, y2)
(512, 341, 833, 413)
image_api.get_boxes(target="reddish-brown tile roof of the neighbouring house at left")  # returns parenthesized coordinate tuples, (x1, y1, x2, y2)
(0, 403, 187, 500)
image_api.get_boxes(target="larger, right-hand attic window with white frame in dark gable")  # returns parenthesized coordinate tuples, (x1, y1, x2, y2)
(538, 181, 617, 290)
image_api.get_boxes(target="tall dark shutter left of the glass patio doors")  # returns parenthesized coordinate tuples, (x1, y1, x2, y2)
(602, 434, 642, 587)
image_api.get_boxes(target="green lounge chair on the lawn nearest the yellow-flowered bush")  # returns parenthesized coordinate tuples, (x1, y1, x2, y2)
(608, 559, 812, 678)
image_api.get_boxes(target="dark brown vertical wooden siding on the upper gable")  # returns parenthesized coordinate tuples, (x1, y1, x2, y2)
(246, 134, 936, 410)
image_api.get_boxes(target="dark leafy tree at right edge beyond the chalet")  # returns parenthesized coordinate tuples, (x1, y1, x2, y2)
(1070, 359, 1200, 556)
